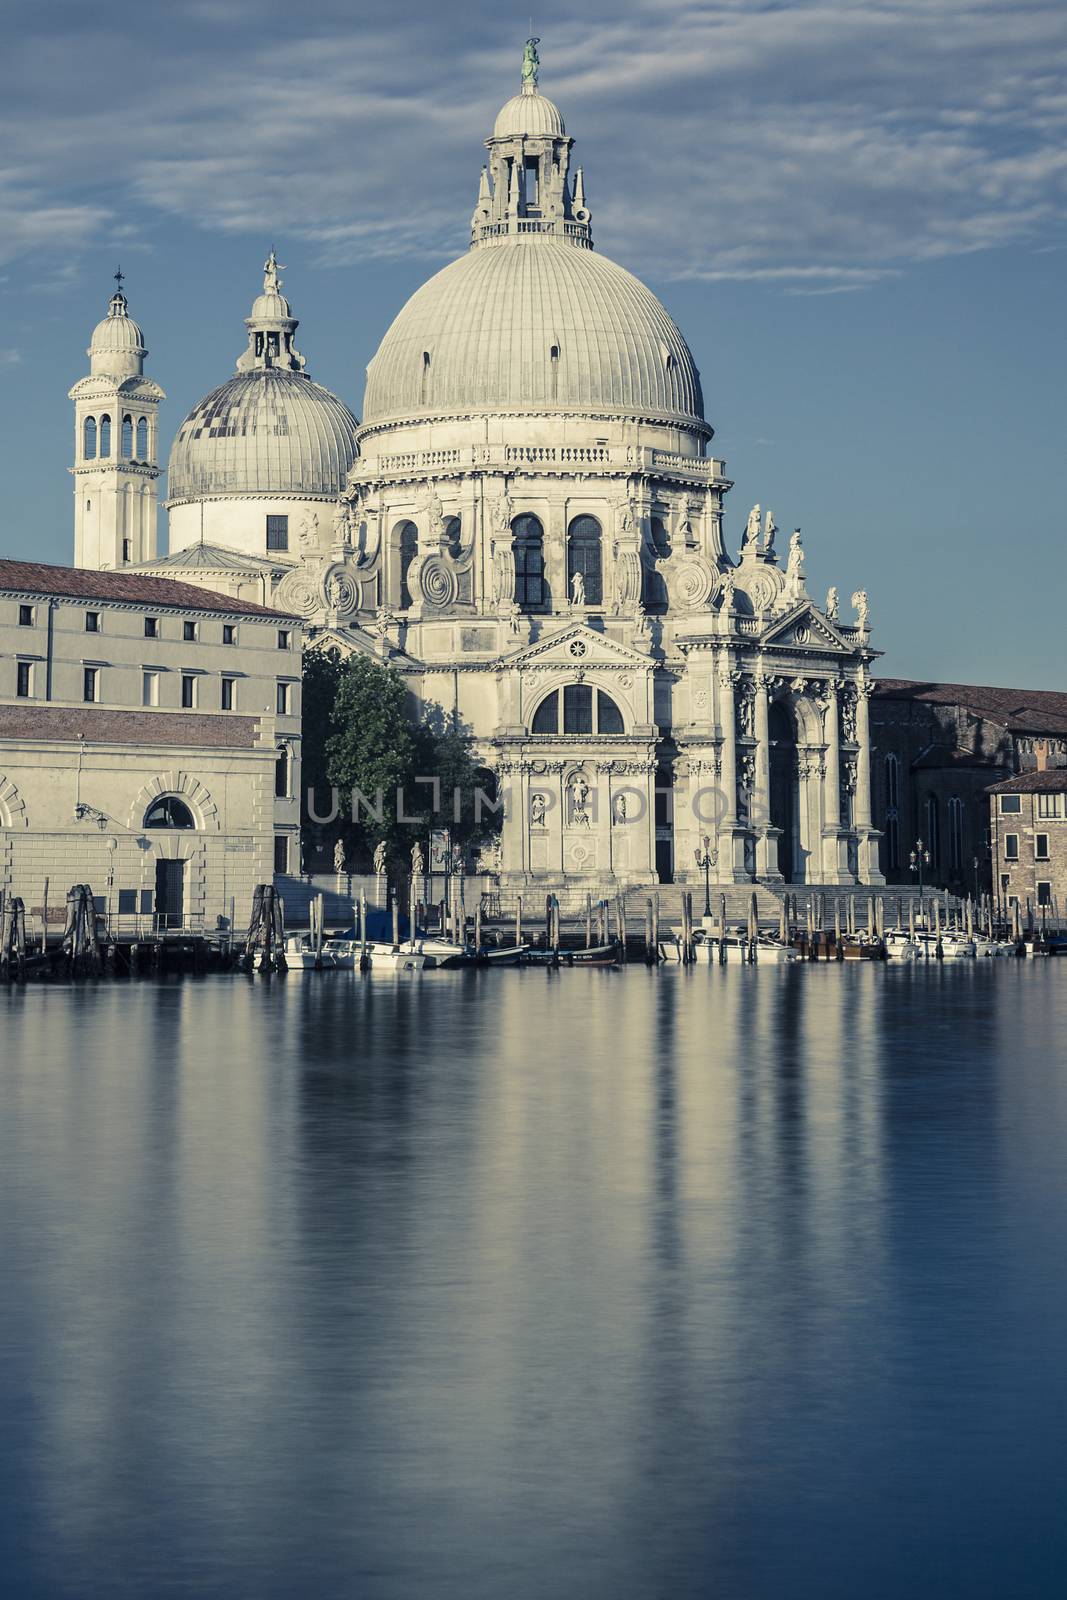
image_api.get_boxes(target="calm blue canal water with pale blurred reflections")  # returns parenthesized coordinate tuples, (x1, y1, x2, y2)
(0, 962, 1067, 1600)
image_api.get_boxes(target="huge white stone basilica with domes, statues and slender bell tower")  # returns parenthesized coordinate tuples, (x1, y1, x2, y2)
(72, 40, 883, 894)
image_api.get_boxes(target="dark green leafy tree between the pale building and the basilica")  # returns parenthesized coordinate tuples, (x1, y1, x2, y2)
(304, 651, 501, 864)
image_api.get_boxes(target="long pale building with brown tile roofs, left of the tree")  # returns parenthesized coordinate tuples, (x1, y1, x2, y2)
(0, 560, 302, 926)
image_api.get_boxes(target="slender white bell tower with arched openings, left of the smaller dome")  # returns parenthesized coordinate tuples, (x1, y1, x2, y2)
(69, 269, 166, 570)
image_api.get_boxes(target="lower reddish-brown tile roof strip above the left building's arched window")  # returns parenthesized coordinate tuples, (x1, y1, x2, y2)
(0, 702, 259, 750)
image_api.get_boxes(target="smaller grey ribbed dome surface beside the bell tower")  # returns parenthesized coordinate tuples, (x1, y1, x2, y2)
(168, 368, 355, 499)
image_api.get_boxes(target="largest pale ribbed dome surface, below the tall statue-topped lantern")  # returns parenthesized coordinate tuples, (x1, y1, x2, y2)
(363, 237, 704, 426)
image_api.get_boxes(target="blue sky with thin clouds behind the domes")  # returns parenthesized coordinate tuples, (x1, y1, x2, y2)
(0, 0, 1067, 688)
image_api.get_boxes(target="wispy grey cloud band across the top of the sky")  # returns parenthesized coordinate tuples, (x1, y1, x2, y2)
(0, 0, 1067, 294)
